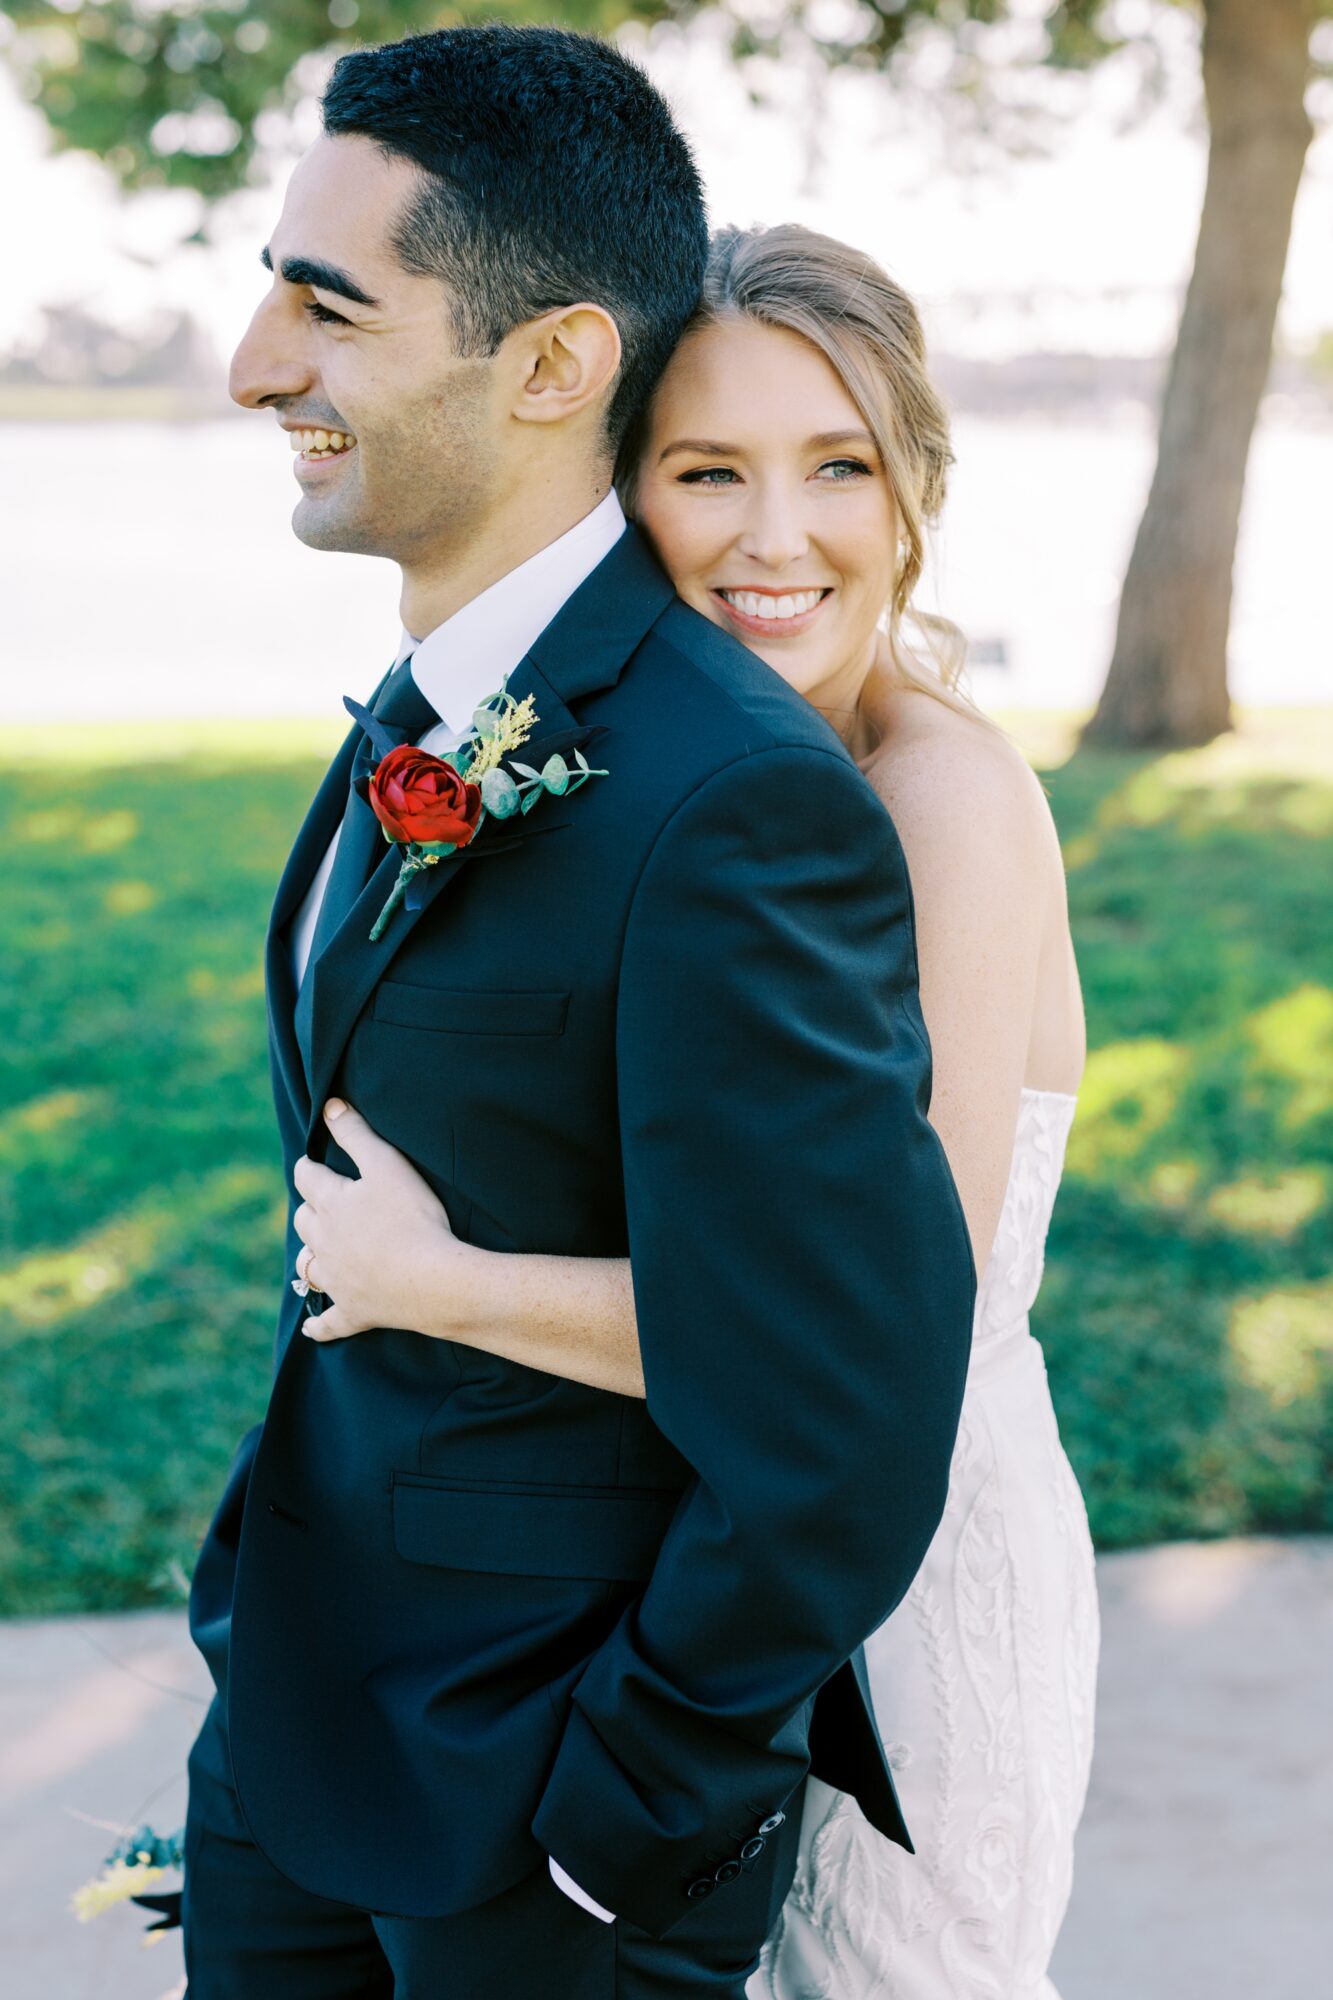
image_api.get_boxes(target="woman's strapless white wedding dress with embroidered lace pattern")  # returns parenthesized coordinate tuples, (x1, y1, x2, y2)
(747, 1088, 1101, 2000)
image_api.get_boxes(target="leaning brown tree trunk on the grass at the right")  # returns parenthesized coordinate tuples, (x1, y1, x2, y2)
(1083, 0, 1315, 748)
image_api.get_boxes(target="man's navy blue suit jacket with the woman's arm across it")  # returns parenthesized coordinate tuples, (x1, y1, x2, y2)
(190, 530, 975, 1936)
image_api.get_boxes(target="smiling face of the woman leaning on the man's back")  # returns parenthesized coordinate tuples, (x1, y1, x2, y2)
(634, 320, 899, 726)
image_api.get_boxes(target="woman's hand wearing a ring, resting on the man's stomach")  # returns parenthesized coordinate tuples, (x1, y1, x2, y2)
(292, 1098, 472, 1340)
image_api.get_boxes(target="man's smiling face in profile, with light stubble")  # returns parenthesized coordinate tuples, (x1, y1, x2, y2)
(230, 134, 504, 570)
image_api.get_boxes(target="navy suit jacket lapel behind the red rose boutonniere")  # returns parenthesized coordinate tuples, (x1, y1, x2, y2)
(294, 528, 675, 1156)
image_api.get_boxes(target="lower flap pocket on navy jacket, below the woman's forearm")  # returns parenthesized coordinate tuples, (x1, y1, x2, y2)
(392, 1472, 681, 1582)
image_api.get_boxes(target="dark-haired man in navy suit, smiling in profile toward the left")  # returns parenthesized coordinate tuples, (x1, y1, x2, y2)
(184, 26, 973, 2000)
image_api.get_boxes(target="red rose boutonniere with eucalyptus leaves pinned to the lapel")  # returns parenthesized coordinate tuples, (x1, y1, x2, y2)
(346, 688, 608, 944)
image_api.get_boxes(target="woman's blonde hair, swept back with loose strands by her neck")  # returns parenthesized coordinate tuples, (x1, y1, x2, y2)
(616, 222, 997, 728)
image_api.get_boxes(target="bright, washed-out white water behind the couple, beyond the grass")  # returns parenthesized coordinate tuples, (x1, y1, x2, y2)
(0, 410, 1333, 722)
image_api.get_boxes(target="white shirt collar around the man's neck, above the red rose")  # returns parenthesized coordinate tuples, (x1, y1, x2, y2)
(394, 488, 624, 732)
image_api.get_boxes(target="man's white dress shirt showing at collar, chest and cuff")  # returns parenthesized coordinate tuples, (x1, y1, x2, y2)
(282, 488, 624, 1924)
